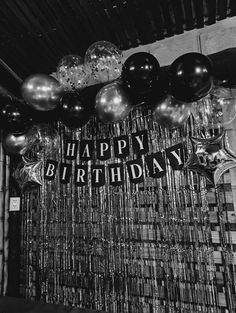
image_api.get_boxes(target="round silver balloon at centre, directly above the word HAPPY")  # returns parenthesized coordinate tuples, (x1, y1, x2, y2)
(95, 82, 133, 123)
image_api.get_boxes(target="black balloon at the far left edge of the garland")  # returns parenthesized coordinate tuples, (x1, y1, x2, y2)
(0, 98, 32, 133)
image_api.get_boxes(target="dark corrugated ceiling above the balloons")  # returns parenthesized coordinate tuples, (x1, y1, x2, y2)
(0, 0, 236, 94)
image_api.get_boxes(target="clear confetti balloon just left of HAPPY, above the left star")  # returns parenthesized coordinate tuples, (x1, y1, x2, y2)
(24, 123, 60, 159)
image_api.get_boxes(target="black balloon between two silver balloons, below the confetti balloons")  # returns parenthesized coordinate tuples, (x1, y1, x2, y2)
(60, 93, 92, 128)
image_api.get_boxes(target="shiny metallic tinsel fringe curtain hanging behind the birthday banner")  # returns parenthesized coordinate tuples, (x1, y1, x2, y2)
(21, 100, 236, 313)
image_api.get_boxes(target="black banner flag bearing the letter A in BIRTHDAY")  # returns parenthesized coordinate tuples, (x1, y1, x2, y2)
(145, 152, 166, 178)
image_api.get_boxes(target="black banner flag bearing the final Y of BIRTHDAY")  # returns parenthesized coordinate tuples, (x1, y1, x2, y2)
(165, 143, 186, 170)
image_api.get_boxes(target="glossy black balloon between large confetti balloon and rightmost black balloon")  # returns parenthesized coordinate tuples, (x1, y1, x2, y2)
(122, 52, 160, 93)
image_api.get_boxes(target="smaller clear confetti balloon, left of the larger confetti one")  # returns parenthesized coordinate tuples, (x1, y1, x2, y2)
(57, 54, 90, 91)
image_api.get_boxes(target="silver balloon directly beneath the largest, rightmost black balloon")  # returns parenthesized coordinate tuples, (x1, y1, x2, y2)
(154, 95, 191, 128)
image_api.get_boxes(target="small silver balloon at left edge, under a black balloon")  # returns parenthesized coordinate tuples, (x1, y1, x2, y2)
(2, 133, 29, 155)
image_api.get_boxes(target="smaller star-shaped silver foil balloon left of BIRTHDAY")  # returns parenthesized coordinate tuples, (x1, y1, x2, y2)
(13, 157, 43, 191)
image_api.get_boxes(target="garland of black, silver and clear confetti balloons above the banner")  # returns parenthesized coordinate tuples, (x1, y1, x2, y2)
(0, 41, 236, 183)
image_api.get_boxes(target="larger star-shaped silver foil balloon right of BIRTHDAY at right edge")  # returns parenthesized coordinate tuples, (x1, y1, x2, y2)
(185, 130, 236, 185)
